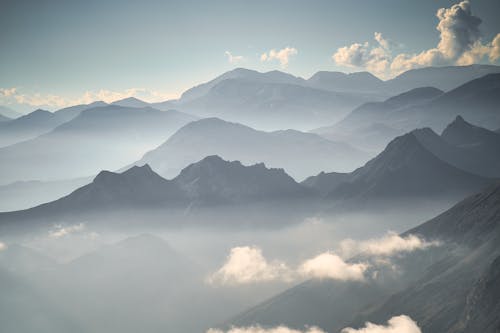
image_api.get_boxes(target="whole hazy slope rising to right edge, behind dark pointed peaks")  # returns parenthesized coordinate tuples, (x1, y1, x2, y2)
(313, 74, 500, 150)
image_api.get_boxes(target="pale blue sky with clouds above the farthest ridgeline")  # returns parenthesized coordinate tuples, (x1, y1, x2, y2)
(0, 0, 500, 112)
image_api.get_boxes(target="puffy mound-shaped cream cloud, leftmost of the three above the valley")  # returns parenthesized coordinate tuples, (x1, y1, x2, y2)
(208, 246, 290, 284)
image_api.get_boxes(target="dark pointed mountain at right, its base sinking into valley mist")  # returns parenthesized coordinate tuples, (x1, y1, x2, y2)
(302, 118, 494, 202)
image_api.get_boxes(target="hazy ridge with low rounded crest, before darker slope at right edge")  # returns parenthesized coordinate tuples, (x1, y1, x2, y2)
(312, 87, 443, 151)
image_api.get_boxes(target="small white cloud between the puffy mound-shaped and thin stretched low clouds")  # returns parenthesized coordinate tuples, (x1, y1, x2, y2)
(299, 252, 369, 281)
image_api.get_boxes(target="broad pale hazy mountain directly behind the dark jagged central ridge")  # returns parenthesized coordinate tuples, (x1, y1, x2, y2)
(135, 118, 369, 179)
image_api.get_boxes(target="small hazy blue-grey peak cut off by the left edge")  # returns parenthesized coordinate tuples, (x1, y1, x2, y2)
(0, 109, 68, 147)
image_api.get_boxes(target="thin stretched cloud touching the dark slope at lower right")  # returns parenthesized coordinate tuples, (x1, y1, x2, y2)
(340, 232, 439, 258)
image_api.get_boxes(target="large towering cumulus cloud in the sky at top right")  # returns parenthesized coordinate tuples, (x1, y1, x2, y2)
(332, 0, 500, 77)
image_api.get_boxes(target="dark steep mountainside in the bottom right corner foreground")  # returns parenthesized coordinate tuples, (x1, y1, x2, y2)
(348, 184, 500, 333)
